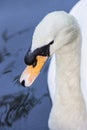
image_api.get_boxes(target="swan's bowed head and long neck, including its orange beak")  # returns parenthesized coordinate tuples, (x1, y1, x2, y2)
(20, 11, 87, 130)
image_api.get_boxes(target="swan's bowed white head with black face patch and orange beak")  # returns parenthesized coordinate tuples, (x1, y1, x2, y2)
(20, 11, 79, 87)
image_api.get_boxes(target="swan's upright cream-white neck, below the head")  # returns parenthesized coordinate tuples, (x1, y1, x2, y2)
(52, 43, 86, 130)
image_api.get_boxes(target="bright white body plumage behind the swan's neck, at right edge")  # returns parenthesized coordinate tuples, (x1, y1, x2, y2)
(70, 0, 87, 108)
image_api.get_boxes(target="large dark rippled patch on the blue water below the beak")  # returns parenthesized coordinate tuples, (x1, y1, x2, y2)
(0, 89, 48, 127)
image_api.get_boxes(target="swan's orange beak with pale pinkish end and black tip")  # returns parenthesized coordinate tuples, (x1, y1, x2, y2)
(20, 56, 48, 87)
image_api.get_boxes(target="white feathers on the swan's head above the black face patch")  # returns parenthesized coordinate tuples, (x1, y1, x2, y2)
(31, 11, 79, 55)
